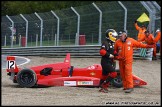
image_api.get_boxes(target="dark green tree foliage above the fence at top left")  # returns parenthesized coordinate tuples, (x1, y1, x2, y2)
(1, 1, 97, 16)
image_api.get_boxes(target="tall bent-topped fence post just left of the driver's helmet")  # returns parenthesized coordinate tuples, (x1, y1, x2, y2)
(92, 3, 102, 45)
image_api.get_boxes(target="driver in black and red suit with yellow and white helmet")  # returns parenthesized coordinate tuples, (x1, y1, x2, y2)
(99, 29, 118, 93)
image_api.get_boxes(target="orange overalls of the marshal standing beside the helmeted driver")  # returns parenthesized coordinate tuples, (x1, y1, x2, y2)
(114, 38, 147, 89)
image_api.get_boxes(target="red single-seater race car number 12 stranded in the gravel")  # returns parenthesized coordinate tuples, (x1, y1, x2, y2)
(6, 53, 147, 88)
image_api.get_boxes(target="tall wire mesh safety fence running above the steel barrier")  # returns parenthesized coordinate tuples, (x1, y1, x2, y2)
(1, 1, 161, 48)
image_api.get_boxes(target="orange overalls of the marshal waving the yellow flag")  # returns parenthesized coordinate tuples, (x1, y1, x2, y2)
(134, 23, 146, 42)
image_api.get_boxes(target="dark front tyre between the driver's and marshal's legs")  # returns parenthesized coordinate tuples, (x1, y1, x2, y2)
(111, 70, 123, 88)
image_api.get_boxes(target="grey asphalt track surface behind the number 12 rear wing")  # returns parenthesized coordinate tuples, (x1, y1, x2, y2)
(1, 55, 30, 69)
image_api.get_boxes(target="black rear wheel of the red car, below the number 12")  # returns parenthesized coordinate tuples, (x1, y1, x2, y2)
(17, 69, 37, 88)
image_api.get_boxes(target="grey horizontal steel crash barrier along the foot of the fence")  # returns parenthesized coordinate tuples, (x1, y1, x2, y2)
(1, 45, 153, 61)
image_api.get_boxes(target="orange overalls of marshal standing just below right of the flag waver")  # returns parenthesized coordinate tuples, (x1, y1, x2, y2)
(143, 34, 156, 57)
